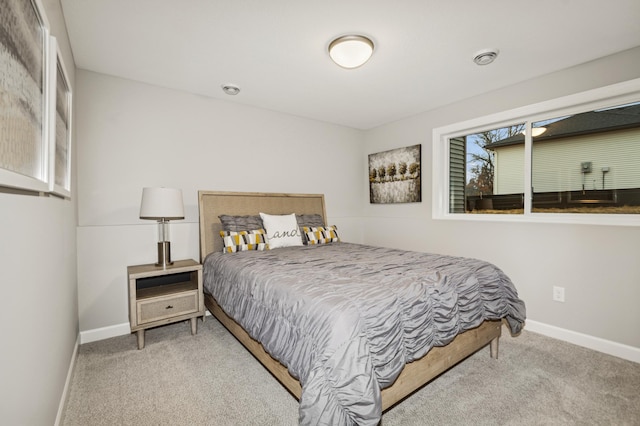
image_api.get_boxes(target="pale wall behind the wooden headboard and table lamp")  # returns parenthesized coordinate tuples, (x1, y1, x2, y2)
(76, 70, 364, 342)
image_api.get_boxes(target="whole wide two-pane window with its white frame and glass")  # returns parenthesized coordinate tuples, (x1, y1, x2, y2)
(433, 79, 640, 225)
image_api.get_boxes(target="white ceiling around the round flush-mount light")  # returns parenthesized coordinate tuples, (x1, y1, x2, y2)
(62, 0, 640, 129)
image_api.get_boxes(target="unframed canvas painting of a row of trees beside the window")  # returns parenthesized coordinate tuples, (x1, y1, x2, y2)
(369, 145, 422, 204)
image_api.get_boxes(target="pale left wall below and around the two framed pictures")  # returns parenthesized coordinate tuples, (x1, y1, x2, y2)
(0, 0, 78, 425)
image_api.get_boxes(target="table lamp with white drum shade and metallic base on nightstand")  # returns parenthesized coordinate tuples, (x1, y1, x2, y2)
(140, 188, 184, 267)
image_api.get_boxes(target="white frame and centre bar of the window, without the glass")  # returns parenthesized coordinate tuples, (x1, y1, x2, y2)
(432, 78, 640, 226)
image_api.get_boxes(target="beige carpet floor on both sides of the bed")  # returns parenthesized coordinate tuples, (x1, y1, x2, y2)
(63, 317, 640, 426)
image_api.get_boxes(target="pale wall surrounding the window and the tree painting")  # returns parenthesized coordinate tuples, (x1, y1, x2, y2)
(361, 48, 640, 361)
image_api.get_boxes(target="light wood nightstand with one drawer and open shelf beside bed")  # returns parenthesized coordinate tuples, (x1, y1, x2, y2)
(127, 259, 205, 349)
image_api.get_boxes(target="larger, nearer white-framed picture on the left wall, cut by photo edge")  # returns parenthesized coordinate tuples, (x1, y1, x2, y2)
(0, 0, 53, 192)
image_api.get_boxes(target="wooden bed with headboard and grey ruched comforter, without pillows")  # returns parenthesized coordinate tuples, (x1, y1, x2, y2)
(198, 191, 525, 425)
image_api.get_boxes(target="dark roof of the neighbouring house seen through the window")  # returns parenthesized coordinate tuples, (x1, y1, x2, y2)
(486, 103, 640, 149)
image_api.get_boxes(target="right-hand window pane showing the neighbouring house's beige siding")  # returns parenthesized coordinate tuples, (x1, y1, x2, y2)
(531, 102, 640, 214)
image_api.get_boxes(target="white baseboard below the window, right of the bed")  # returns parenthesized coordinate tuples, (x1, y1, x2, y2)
(525, 320, 640, 363)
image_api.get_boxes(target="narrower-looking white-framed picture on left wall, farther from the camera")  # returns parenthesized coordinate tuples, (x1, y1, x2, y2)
(49, 37, 72, 197)
